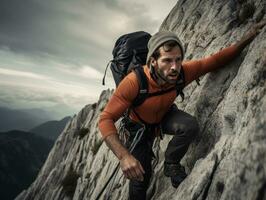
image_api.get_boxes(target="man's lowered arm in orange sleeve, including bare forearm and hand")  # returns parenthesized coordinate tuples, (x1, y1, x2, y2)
(99, 74, 144, 180)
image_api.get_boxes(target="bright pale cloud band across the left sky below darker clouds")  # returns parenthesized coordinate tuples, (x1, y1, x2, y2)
(0, 62, 105, 109)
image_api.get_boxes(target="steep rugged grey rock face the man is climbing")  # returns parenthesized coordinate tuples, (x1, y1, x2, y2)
(16, 0, 266, 200)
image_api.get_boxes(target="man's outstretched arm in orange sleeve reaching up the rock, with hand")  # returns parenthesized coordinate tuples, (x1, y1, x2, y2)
(182, 19, 266, 85)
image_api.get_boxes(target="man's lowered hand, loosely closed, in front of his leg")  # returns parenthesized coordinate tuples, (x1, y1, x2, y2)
(120, 154, 145, 181)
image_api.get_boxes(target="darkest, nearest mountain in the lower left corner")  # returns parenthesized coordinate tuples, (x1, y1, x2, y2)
(0, 130, 53, 200)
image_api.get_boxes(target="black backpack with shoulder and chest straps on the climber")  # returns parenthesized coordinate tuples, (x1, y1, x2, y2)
(103, 31, 185, 110)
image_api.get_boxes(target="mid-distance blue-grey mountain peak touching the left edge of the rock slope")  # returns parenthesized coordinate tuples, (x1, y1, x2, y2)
(30, 116, 71, 140)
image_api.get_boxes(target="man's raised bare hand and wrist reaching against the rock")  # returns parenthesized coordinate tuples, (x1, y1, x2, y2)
(236, 19, 266, 50)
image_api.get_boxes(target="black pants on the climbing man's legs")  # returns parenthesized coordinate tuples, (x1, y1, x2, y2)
(128, 105, 199, 200)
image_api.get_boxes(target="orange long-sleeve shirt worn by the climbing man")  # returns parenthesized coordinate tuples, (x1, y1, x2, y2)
(99, 45, 240, 138)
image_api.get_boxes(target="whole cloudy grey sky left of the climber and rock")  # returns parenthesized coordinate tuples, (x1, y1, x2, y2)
(0, 0, 177, 117)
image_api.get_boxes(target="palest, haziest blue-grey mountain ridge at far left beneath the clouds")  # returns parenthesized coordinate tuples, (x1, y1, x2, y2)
(0, 107, 55, 132)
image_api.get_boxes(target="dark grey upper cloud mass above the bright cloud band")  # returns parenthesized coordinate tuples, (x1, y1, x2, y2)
(0, 0, 177, 72)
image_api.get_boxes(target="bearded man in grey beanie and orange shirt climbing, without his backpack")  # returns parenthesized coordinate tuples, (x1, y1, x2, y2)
(99, 20, 266, 200)
